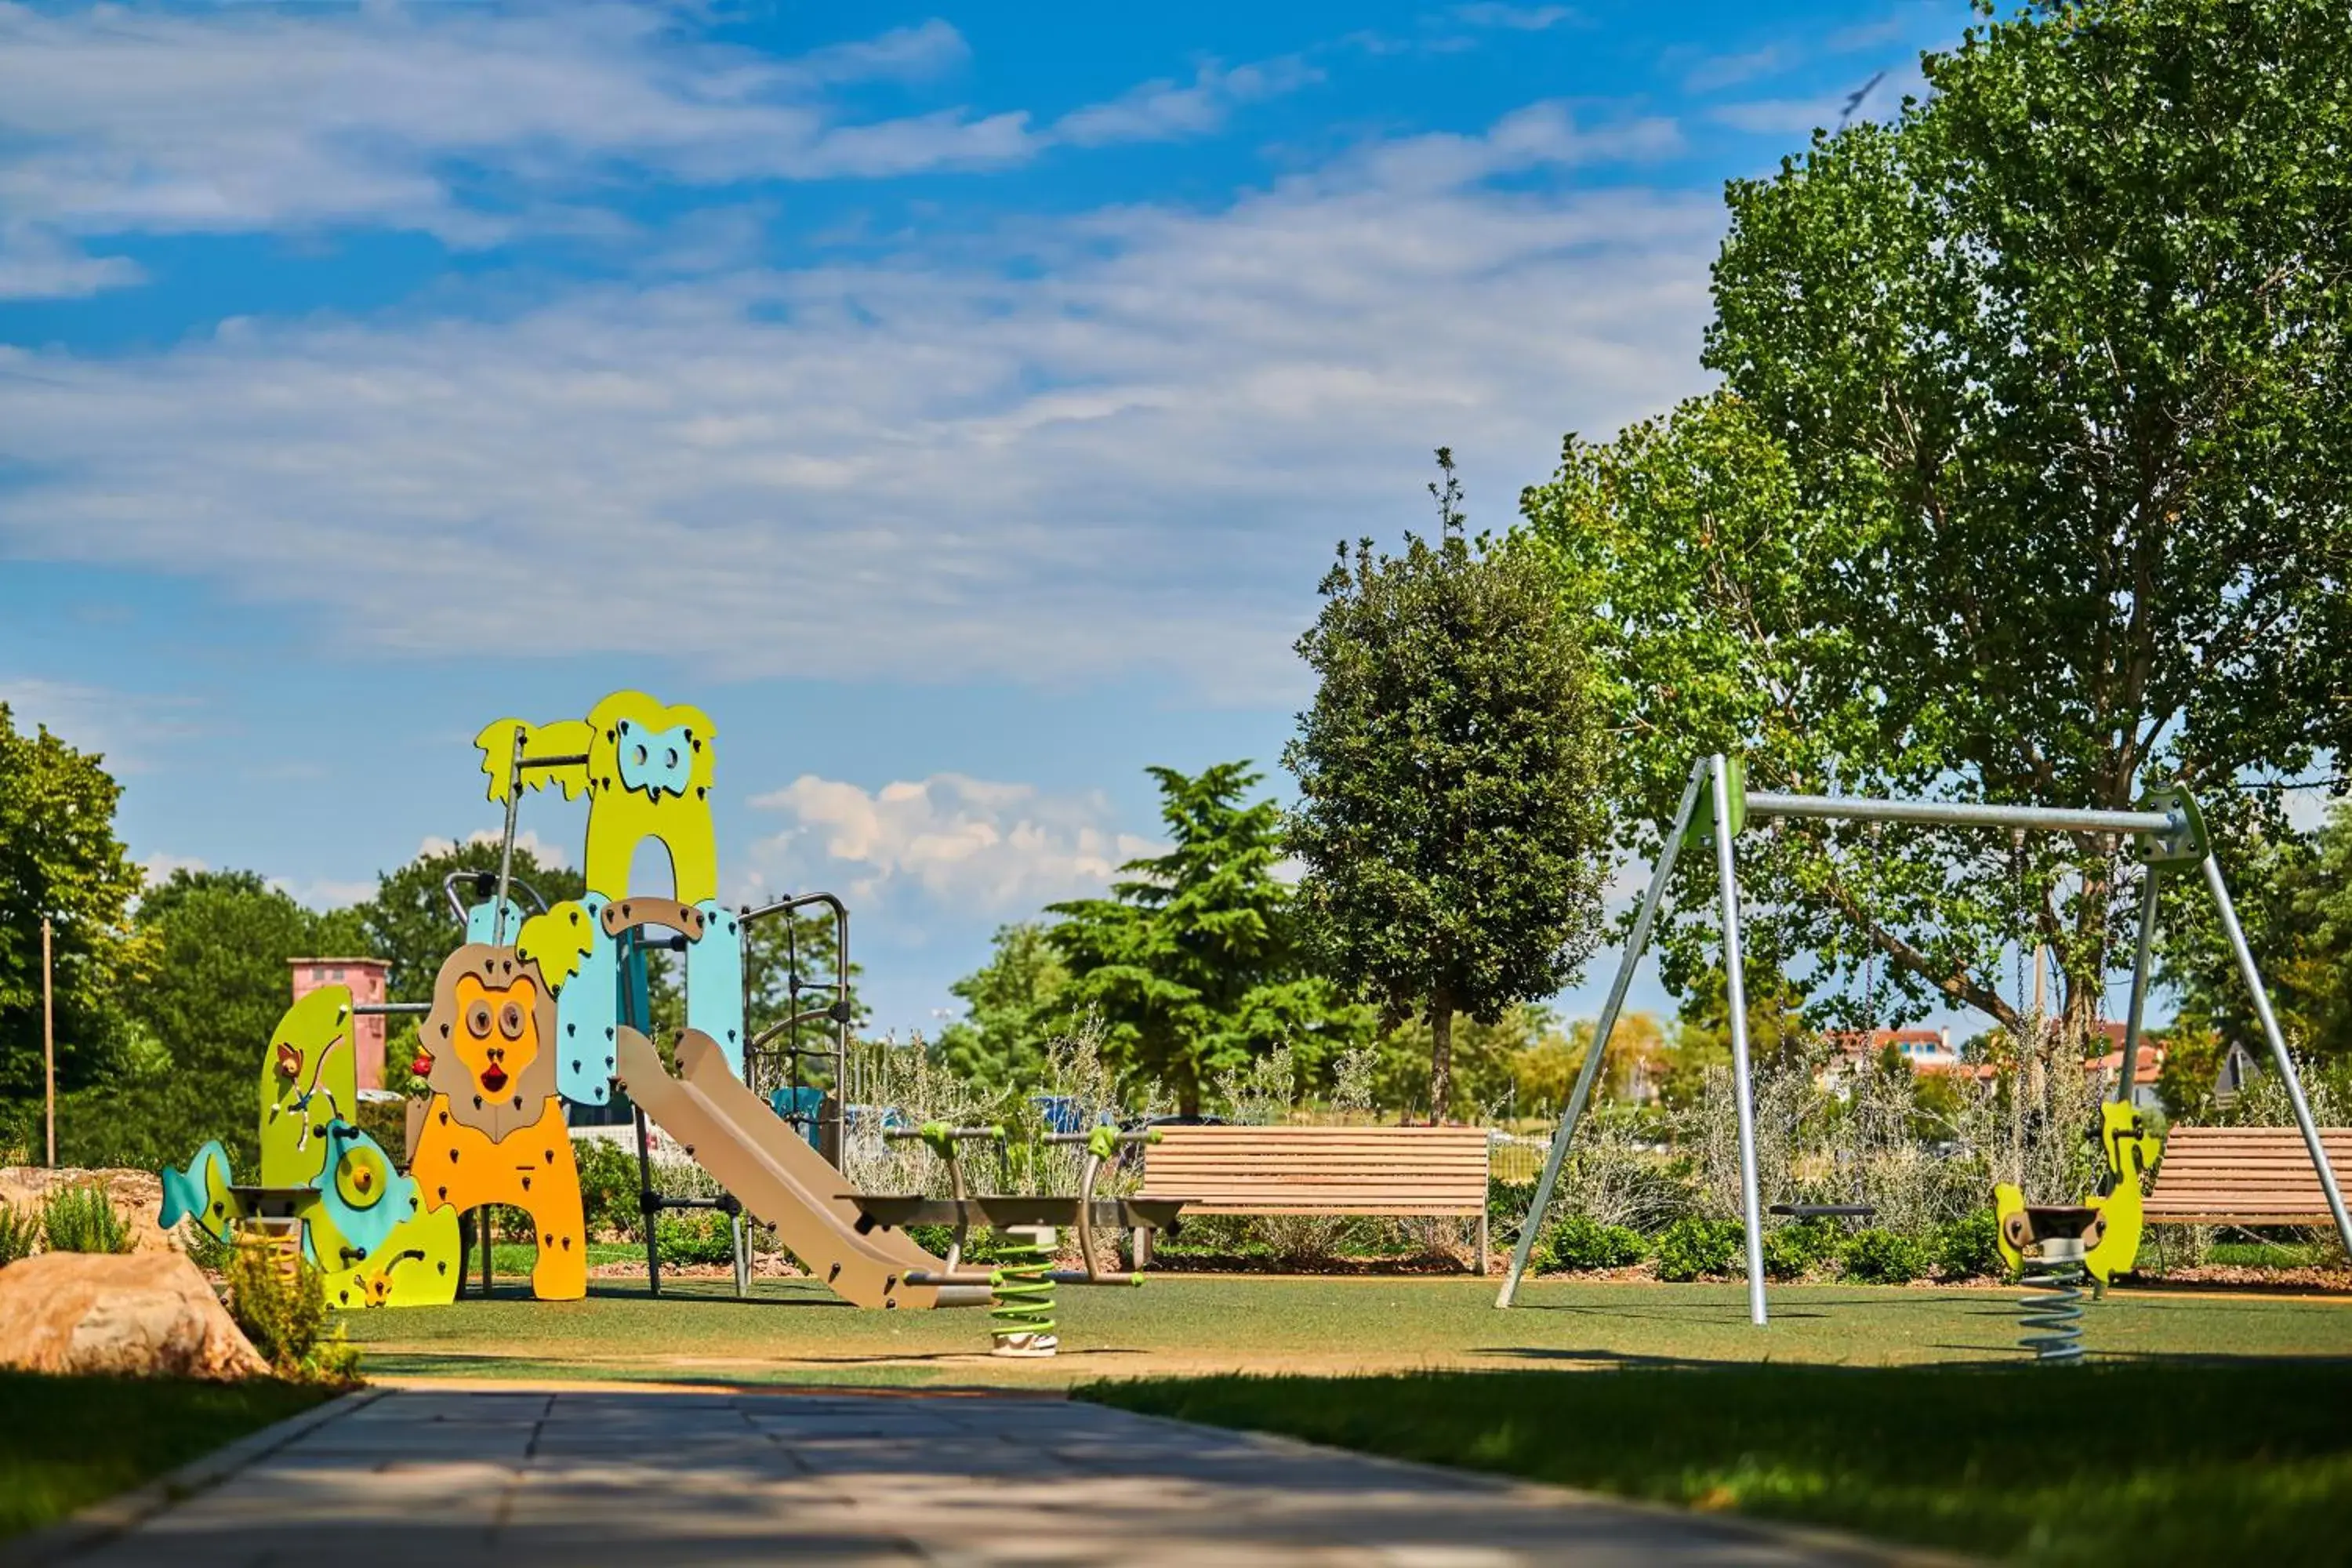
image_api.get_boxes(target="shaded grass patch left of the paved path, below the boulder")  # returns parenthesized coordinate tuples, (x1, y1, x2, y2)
(0, 1373, 327, 1535)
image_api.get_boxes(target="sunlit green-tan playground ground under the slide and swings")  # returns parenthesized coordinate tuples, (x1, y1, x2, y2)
(341, 1269, 2352, 1385)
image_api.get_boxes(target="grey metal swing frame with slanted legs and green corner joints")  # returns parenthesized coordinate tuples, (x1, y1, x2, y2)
(1494, 755, 2352, 1326)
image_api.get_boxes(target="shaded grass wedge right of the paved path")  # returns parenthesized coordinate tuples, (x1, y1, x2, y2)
(1077, 1361, 2352, 1568)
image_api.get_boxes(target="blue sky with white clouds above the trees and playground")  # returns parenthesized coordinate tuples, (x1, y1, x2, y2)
(0, 0, 1969, 1029)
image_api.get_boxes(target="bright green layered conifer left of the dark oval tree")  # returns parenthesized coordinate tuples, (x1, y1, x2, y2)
(1047, 762, 1367, 1114)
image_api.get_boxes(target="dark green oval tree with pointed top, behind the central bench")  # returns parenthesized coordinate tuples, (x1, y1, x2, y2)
(1282, 449, 1606, 1114)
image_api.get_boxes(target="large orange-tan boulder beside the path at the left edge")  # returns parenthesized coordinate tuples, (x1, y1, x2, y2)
(0, 1250, 270, 1377)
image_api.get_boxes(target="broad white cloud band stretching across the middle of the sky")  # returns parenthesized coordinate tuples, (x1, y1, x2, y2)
(0, 103, 1722, 703)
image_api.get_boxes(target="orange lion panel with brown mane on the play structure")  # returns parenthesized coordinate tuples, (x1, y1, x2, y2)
(409, 942, 588, 1300)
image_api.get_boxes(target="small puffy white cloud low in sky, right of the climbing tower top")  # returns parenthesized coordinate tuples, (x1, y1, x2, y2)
(750, 774, 1157, 912)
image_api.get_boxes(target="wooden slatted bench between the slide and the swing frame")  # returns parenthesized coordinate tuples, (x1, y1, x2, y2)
(1136, 1126, 1486, 1274)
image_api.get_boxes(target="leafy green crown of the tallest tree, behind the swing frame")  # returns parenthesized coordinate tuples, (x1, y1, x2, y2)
(1524, 0, 2352, 1039)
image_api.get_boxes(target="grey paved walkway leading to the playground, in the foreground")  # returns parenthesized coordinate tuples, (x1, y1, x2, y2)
(50, 1387, 1947, 1568)
